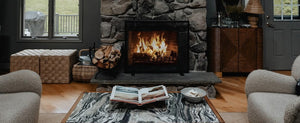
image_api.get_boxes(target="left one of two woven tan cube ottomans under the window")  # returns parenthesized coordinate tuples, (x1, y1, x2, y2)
(10, 49, 49, 74)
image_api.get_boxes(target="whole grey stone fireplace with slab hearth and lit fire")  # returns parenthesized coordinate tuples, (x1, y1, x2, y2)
(91, 0, 221, 97)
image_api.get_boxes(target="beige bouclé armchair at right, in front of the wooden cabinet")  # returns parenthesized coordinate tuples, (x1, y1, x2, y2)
(245, 56, 300, 123)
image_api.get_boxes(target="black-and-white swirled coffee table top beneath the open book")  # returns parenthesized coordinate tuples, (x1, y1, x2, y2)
(67, 93, 219, 123)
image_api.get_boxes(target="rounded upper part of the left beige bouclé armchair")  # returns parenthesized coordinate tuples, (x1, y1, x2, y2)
(0, 70, 42, 95)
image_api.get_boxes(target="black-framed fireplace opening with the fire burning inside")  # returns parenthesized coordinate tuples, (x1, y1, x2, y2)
(125, 21, 189, 75)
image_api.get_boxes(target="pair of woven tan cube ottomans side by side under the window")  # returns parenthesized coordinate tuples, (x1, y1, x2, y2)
(10, 49, 76, 83)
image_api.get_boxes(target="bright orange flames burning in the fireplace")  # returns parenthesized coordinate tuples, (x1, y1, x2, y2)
(136, 32, 168, 59)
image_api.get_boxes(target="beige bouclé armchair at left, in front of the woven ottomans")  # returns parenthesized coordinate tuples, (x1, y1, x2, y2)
(0, 70, 42, 123)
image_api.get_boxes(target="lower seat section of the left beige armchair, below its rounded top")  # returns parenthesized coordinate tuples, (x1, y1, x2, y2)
(0, 92, 40, 123)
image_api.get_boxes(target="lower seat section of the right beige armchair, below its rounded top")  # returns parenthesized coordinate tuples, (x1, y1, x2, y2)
(248, 92, 297, 123)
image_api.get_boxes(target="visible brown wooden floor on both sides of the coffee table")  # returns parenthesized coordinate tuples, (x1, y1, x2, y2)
(40, 72, 290, 113)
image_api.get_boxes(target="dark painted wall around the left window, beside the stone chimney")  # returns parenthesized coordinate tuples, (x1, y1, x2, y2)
(0, 0, 101, 69)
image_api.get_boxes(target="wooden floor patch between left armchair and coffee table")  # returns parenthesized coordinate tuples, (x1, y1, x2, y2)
(40, 82, 97, 113)
